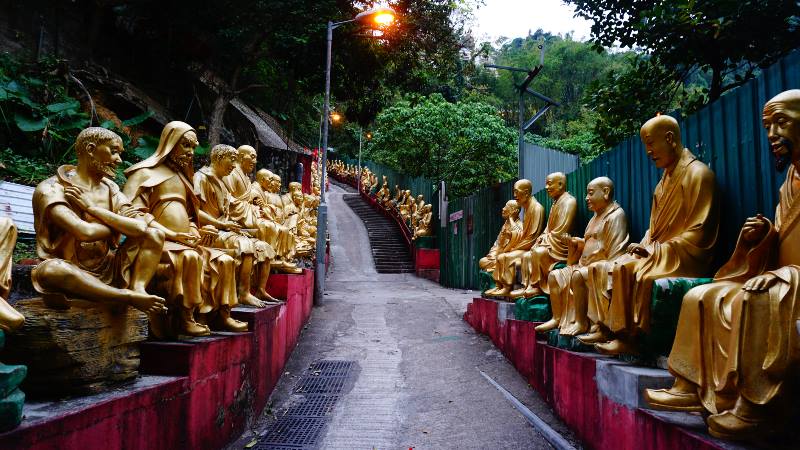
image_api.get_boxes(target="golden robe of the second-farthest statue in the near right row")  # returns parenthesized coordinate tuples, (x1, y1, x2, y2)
(493, 196, 544, 287)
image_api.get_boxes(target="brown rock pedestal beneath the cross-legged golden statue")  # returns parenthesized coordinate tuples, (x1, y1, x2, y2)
(0, 298, 148, 398)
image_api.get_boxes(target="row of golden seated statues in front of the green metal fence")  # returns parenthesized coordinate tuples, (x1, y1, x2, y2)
(480, 90, 800, 439)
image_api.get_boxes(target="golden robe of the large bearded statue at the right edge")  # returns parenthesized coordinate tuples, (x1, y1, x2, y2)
(669, 166, 800, 414)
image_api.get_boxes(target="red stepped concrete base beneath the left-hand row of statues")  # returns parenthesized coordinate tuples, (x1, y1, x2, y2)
(0, 270, 314, 450)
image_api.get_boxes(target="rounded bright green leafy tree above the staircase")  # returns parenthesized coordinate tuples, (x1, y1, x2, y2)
(365, 94, 516, 197)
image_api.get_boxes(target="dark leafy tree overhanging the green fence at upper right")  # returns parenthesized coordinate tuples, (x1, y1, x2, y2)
(565, 0, 800, 103)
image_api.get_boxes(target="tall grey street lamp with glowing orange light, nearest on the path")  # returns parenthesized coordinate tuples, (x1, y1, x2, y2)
(314, 7, 396, 304)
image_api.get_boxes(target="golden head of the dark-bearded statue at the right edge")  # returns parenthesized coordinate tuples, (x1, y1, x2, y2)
(762, 89, 800, 171)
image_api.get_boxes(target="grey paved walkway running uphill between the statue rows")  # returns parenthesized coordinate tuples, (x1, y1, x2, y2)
(231, 187, 574, 449)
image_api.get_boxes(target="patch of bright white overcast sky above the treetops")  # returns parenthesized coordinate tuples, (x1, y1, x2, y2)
(472, 0, 591, 42)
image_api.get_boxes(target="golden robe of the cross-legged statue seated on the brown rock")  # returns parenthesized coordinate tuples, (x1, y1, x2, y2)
(31, 165, 152, 295)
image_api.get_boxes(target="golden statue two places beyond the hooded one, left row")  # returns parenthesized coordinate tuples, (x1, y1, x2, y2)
(224, 145, 302, 276)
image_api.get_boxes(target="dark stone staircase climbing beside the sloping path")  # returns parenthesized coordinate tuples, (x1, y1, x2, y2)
(342, 194, 414, 273)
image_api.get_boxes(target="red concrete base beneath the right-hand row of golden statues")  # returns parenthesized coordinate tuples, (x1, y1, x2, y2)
(464, 298, 724, 450)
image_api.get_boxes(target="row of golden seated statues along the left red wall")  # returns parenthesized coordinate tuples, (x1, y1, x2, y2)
(0, 121, 319, 429)
